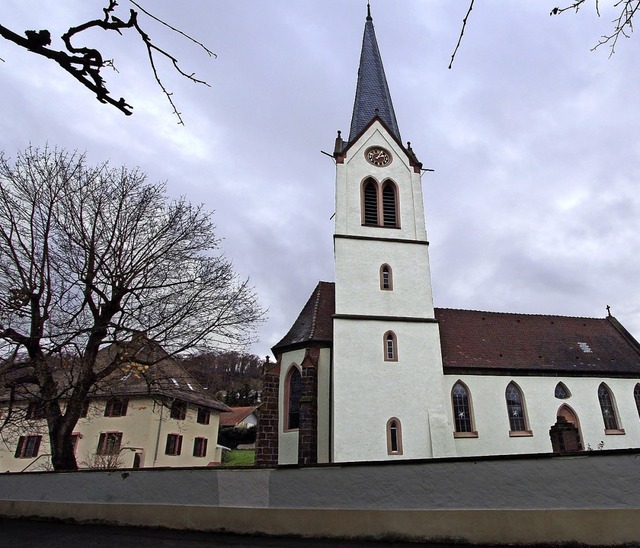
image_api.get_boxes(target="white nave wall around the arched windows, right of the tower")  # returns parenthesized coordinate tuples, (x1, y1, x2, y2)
(444, 375, 640, 456)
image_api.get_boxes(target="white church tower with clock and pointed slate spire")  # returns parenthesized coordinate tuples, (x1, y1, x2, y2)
(331, 7, 454, 462)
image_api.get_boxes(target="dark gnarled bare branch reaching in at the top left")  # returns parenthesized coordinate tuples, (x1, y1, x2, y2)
(0, 0, 215, 124)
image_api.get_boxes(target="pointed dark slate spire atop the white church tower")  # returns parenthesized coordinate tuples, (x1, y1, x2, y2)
(349, 4, 402, 142)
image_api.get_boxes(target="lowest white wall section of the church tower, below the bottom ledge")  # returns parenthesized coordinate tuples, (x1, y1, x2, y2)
(333, 319, 454, 462)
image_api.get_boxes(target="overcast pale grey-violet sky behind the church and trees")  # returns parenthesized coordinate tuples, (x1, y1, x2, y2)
(0, 0, 640, 356)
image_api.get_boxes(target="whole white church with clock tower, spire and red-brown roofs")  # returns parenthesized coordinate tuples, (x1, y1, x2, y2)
(256, 8, 640, 466)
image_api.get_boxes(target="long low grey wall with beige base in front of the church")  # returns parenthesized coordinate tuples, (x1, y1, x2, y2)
(0, 451, 640, 546)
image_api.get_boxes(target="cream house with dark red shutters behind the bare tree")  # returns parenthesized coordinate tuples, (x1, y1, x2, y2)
(0, 337, 229, 472)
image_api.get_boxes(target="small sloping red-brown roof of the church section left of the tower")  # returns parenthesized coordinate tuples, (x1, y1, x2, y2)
(271, 282, 335, 355)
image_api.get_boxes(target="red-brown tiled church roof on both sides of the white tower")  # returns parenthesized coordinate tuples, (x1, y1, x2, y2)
(273, 282, 640, 376)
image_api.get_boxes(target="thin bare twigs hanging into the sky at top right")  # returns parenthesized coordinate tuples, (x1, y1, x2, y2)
(449, 0, 640, 68)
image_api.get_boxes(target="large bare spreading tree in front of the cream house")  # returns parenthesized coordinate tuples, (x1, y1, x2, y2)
(0, 148, 262, 470)
